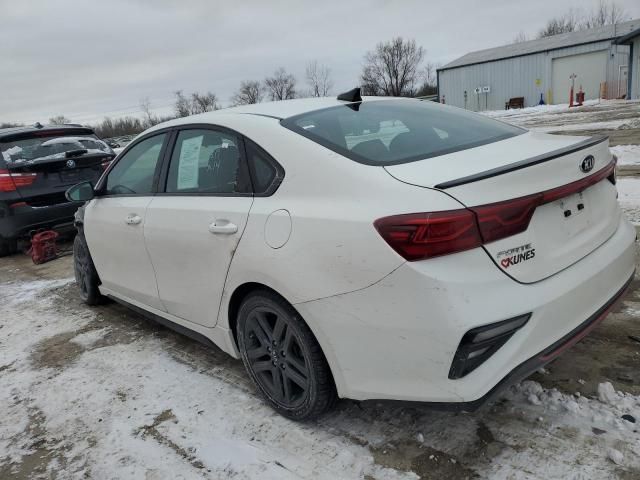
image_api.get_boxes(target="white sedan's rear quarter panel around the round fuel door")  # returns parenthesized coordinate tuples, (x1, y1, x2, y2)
(219, 118, 460, 330)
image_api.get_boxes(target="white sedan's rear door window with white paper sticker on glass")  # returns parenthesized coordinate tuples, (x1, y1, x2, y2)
(166, 129, 251, 194)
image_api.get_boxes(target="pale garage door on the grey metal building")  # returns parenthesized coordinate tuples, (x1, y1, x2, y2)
(551, 50, 607, 103)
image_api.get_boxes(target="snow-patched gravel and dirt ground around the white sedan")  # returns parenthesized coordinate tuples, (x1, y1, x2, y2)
(0, 102, 640, 480)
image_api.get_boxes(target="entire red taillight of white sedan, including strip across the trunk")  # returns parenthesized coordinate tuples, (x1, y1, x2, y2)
(374, 158, 616, 261)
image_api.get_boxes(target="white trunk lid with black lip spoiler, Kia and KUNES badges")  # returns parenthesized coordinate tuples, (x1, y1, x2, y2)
(384, 132, 621, 283)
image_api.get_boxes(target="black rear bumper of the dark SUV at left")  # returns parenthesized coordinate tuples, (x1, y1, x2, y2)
(0, 202, 82, 238)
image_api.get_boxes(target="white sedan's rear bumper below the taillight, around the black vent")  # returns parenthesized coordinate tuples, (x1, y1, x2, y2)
(295, 219, 636, 409)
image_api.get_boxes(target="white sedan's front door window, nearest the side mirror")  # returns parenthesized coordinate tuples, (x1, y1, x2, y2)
(107, 133, 166, 195)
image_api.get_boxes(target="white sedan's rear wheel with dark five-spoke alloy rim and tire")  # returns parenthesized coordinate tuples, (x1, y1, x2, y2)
(237, 291, 337, 420)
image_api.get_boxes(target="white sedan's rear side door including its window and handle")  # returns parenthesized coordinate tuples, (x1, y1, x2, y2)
(144, 128, 253, 326)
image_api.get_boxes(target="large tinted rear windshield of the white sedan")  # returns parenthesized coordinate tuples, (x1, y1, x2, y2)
(282, 99, 526, 165)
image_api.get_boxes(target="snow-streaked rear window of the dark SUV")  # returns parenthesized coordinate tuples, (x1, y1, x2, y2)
(0, 134, 113, 163)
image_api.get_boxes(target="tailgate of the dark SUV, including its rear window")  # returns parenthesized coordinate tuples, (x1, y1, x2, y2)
(1, 129, 115, 207)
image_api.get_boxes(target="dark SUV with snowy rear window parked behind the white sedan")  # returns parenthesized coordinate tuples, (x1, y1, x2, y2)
(0, 124, 115, 257)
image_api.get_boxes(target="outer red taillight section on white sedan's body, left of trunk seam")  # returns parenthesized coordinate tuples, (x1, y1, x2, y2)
(374, 210, 482, 261)
